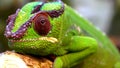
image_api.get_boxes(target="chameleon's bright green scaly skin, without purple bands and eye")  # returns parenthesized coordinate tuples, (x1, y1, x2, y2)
(5, 2, 120, 68)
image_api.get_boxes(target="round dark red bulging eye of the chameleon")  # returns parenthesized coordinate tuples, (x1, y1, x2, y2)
(33, 13, 51, 36)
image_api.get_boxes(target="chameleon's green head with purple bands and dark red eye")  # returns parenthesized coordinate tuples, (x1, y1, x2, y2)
(5, 0, 64, 55)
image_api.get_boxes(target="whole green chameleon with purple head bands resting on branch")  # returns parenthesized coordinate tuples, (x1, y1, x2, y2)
(5, 0, 120, 68)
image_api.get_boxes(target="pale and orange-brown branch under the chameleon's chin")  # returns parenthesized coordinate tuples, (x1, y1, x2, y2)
(0, 51, 53, 68)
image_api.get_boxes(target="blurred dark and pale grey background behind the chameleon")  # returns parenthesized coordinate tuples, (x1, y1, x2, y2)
(0, 0, 120, 52)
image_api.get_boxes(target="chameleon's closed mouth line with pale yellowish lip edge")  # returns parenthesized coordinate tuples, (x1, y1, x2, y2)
(9, 37, 58, 43)
